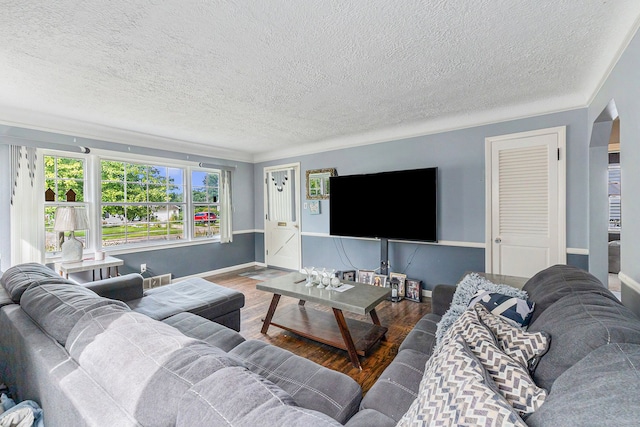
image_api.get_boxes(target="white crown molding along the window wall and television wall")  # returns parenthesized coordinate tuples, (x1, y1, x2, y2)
(0, 92, 587, 163)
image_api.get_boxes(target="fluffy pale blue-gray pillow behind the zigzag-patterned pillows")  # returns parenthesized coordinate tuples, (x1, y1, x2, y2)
(436, 273, 528, 344)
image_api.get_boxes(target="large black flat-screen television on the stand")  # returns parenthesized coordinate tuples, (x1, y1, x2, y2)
(329, 167, 438, 242)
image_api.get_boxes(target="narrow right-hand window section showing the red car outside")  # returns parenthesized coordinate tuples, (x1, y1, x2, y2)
(191, 171, 220, 238)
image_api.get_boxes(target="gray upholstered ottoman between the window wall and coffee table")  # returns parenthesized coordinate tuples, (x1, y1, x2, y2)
(126, 277, 244, 331)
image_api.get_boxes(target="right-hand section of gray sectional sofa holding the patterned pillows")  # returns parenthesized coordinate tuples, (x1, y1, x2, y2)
(349, 265, 640, 427)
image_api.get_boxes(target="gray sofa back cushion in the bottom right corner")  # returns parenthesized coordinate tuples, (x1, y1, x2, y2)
(527, 344, 640, 427)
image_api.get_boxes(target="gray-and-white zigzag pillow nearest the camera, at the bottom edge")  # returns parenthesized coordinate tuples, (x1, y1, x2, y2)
(397, 336, 526, 427)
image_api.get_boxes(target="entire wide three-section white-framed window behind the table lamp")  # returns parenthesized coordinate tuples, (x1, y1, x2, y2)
(38, 151, 228, 257)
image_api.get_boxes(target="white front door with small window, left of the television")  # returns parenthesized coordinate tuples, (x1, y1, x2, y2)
(265, 164, 302, 270)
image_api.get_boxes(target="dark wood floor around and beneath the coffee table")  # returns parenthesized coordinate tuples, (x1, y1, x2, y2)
(206, 268, 431, 393)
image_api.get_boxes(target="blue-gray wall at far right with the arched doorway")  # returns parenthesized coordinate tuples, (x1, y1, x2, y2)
(588, 25, 640, 314)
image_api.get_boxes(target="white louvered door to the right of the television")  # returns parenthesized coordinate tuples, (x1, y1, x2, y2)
(486, 127, 566, 277)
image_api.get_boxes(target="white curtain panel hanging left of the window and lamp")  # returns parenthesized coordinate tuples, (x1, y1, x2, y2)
(11, 146, 45, 265)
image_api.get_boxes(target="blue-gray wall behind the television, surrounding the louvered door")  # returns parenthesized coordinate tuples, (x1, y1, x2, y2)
(255, 109, 589, 289)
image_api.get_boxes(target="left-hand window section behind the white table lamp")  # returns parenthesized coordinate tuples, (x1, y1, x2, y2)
(44, 155, 88, 254)
